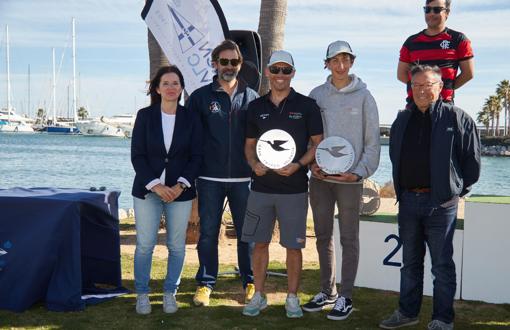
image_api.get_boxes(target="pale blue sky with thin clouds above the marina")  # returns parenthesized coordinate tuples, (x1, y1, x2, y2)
(0, 0, 510, 124)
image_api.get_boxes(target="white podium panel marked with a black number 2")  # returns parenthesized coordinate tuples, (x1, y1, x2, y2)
(334, 216, 464, 299)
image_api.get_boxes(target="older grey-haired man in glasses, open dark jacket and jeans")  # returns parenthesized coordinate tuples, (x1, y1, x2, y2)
(379, 65, 480, 329)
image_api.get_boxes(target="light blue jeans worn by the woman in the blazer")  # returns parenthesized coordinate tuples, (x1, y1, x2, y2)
(133, 193, 192, 294)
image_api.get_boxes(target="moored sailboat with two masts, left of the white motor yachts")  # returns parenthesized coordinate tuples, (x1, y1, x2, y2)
(43, 17, 80, 134)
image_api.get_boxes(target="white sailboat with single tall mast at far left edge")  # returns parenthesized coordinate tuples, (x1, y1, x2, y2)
(0, 26, 34, 133)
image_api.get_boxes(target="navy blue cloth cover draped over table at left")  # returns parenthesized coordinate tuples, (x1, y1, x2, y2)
(0, 188, 122, 312)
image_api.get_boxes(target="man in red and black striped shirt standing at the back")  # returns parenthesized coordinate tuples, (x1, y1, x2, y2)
(397, 0, 474, 102)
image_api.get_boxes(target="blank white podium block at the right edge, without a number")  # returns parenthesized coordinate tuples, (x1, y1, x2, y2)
(462, 198, 510, 303)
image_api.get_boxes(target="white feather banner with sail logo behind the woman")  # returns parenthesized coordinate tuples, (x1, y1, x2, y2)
(142, 0, 228, 94)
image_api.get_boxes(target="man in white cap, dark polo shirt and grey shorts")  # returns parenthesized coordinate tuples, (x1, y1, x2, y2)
(242, 51, 322, 318)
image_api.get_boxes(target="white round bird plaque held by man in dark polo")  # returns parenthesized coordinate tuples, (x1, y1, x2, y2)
(257, 129, 296, 169)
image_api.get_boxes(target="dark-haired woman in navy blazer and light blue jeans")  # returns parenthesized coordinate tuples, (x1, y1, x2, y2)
(131, 66, 202, 314)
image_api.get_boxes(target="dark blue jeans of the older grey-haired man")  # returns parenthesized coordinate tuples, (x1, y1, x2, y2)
(398, 191, 458, 323)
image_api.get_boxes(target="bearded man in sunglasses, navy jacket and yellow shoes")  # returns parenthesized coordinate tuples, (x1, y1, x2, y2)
(188, 40, 258, 306)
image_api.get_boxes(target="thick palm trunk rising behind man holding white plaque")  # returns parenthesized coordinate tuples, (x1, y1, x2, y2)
(258, 0, 287, 95)
